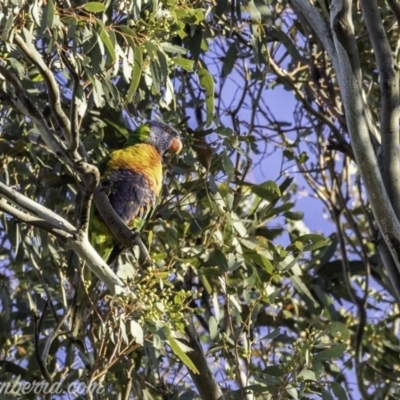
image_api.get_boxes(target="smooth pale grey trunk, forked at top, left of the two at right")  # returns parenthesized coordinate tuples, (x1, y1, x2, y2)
(292, 0, 400, 300)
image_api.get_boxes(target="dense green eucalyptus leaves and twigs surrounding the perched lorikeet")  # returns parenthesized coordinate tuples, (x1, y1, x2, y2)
(0, 0, 400, 399)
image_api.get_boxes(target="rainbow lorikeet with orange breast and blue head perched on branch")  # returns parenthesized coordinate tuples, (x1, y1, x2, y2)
(89, 121, 182, 261)
